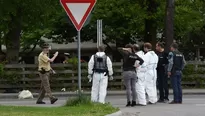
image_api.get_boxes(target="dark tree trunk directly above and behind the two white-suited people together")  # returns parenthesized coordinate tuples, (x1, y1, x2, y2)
(144, 0, 159, 45)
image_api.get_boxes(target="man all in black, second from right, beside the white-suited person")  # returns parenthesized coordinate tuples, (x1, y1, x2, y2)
(156, 42, 169, 103)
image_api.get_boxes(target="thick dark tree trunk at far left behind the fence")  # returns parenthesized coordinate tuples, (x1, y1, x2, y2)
(5, 10, 21, 64)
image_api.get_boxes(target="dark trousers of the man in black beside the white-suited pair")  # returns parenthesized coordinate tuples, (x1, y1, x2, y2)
(157, 70, 169, 100)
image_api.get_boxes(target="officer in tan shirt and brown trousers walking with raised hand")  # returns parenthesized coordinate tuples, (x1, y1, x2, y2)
(36, 44, 58, 104)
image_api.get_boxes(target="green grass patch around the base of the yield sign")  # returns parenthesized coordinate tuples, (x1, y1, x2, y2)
(0, 96, 119, 116)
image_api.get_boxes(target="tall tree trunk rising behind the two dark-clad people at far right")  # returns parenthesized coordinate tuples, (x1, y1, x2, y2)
(165, 0, 174, 51)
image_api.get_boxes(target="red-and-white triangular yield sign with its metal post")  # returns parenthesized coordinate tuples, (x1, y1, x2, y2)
(60, 0, 97, 93)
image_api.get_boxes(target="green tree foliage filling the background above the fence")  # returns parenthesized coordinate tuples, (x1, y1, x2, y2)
(0, 0, 205, 63)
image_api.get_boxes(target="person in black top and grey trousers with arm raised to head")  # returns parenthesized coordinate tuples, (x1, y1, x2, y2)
(119, 44, 144, 107)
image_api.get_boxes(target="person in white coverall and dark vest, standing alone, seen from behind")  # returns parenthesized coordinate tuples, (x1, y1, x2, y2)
(88, 46, 113, 104)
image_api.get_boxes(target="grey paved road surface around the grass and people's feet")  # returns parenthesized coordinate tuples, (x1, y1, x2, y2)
(0, 95, 205, 116)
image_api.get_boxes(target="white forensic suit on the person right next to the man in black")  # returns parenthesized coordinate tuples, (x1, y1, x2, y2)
(143, 51, 159, 103)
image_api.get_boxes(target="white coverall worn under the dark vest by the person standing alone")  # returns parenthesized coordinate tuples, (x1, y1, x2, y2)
(88, 52, 113, 104)
